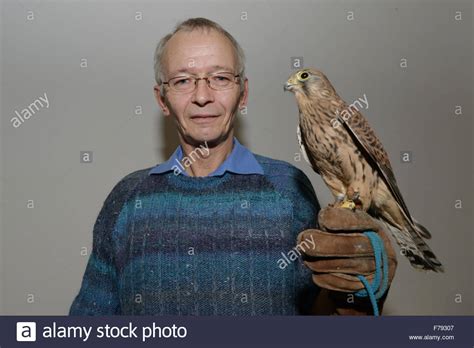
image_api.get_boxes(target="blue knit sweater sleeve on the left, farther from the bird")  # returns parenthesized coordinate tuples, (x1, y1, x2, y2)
(69, 171, 144, 315)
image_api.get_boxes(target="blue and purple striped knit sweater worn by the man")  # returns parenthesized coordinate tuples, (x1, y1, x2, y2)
(69, 155, 319, 316)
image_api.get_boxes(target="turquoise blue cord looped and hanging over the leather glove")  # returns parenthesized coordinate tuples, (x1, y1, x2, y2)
(355, 231, 388, 316)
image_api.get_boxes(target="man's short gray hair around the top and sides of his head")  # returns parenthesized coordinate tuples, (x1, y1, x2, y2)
(153, 17, 246, 94)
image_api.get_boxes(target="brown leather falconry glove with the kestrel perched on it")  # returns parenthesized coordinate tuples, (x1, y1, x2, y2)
(298, 207, 397, 315)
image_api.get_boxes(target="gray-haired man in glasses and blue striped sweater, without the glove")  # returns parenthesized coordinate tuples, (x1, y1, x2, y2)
(70, 18, 396, 315)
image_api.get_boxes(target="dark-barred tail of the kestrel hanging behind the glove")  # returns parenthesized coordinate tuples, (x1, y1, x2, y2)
(387, 223, 444, 272)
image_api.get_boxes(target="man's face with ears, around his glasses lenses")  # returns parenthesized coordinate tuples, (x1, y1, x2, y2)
(155, 30, 248, 143)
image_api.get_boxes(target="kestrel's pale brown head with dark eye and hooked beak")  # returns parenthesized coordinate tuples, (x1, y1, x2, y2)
(283, 68, 336, 100)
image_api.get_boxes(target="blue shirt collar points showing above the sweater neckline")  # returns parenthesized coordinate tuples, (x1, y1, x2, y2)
(148, 137, 263, 176)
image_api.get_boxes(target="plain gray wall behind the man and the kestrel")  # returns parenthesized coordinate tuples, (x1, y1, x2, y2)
(0, 0, 474, 315)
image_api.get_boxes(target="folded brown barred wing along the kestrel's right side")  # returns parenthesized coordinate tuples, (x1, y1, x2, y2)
(338, 109, 414, 224)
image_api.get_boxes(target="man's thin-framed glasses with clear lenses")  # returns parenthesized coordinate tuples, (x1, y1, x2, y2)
(163, 72, 240, 93)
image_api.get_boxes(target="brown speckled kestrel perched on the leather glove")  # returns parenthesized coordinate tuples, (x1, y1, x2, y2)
(284, 69, 444, 272)
